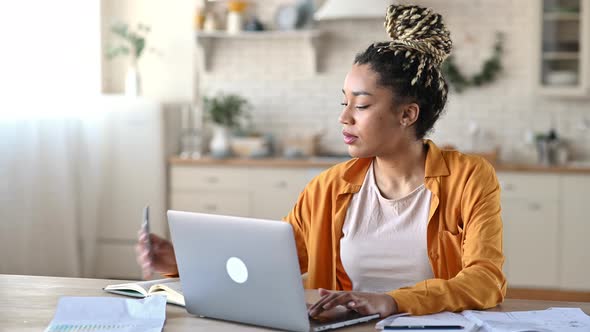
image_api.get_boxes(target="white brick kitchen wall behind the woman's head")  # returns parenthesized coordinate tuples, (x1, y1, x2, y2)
(198, 0, 590, 161)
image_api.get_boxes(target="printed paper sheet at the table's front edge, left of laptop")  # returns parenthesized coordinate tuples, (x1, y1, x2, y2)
(45, 295, 166, 332)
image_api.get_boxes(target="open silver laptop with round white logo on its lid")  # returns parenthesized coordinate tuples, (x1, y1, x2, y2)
(168, 211, 379, 331)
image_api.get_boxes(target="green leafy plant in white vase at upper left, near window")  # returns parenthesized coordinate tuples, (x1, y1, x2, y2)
(106, 22, 150, 96)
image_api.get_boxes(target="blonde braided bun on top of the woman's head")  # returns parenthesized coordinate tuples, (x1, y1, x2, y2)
(385, 5, 453, 65)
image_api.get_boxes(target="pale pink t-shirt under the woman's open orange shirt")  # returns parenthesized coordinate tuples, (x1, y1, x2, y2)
(340, 163, 434, 292)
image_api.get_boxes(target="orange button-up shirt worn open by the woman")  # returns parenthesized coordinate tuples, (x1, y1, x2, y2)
(285, 140, 506, 315)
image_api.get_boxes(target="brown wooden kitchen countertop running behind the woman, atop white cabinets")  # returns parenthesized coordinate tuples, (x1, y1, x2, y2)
(169, 157, 590, 175)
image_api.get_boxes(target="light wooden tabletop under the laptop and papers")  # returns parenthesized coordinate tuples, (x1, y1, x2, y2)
(0, 275, 590, 332)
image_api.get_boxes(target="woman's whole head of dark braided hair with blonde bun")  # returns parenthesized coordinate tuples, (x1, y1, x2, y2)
(354, 5, 453, 138)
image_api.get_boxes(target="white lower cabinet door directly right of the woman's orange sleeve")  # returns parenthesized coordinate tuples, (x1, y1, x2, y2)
(498, 173, 559, 288)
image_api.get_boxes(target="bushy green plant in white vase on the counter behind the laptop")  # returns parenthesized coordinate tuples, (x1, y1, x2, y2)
(203, 94, 249, 158)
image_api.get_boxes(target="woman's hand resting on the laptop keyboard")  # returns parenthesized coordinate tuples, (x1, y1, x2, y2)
(308, 288, 397, 317)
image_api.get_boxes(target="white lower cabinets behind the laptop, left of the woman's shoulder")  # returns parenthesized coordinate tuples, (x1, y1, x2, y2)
(170, 164, 326, 220)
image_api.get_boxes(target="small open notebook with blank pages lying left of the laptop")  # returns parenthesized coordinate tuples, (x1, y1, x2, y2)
(103, 278, 185, 307)
